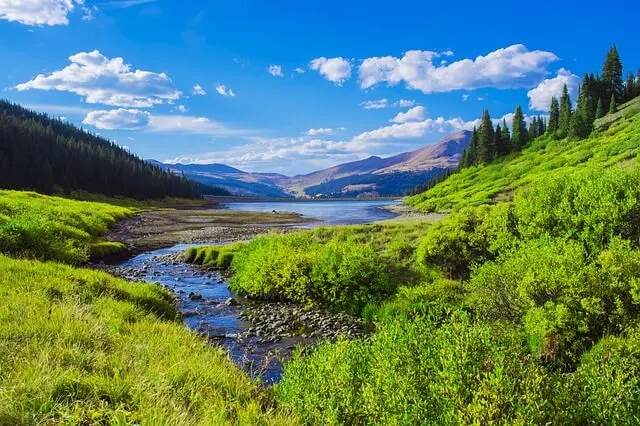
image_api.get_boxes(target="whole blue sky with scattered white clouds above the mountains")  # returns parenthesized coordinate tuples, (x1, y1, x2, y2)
(0, 0, 640, 175)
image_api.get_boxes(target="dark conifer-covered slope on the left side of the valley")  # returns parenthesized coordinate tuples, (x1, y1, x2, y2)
(0, 100, 228, 199)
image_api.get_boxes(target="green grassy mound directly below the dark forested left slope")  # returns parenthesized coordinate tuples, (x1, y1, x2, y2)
(0, 190, 134, 264)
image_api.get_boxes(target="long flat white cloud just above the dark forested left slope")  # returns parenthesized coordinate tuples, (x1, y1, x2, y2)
(83, 108, 245, 136)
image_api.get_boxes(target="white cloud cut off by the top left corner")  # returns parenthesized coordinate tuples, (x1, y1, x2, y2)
(0, 0, 84, 26)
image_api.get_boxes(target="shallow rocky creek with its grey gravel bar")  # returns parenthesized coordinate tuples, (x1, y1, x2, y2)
(112, 244, 364, 384)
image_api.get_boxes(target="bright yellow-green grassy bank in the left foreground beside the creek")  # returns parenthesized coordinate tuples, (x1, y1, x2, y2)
(0, 255, 295, 425)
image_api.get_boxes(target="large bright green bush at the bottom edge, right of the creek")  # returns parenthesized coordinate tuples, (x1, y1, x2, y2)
(277, 312, 553, 425)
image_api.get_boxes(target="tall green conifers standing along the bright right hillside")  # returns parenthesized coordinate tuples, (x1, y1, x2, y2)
(459, 45, 640, 168)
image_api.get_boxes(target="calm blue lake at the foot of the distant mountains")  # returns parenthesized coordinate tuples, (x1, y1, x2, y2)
(226, 200, 398, 226)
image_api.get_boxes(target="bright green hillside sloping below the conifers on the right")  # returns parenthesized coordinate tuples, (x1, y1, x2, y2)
(407, 98, 640, 211)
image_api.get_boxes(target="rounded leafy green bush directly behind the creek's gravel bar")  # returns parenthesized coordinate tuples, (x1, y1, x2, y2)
(230, 234, 393, 313)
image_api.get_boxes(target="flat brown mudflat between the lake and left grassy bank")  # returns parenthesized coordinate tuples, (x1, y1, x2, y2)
(107, 208, 310, 258)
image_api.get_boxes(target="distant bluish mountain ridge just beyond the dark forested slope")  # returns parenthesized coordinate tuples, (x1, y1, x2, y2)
(149, 160, 292, 198)
